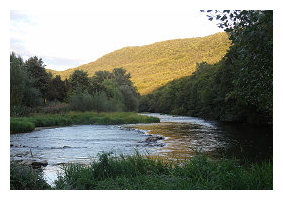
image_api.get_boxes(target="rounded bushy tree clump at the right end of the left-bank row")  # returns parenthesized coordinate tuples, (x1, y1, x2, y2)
(70, 68, 139, 112)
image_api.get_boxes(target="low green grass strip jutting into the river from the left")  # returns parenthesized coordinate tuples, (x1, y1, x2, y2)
(10, 112, 160, 133)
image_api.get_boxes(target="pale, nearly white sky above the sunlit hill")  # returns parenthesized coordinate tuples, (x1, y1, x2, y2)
(10, 10, 222, 70)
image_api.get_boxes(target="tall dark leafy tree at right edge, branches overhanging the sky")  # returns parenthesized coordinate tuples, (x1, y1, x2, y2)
(204, 10, 273, 118)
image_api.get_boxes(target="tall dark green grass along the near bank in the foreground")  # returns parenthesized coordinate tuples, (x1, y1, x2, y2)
(10, 154, 273, 190)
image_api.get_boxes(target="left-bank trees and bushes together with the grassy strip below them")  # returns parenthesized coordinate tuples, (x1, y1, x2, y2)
(10, 53, 151, 133)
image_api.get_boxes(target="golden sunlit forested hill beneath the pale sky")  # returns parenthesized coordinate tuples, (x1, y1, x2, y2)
(49, 32, 230, 94)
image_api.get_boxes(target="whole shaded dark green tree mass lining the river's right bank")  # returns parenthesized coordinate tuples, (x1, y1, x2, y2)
(140, 11, 273, 125)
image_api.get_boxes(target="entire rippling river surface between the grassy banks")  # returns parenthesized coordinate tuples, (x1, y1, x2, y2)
(10, 113, 273, 183)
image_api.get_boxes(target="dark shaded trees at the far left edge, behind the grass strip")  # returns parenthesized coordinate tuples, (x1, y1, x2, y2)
(10, 52, 66, 116)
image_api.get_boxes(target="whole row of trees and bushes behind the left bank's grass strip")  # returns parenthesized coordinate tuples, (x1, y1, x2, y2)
(10, 52, 140, 117)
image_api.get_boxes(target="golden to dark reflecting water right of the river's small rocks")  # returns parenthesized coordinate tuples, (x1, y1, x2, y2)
(135, 113, 273, 161)
